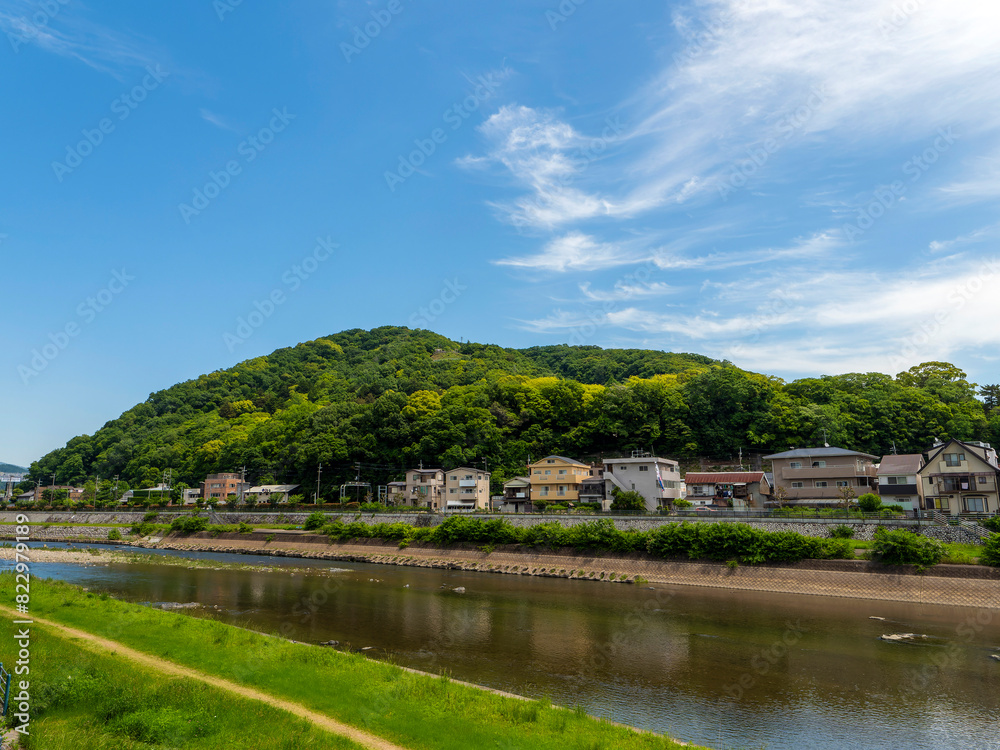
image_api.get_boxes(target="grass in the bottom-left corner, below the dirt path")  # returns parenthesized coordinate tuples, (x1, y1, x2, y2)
(0, 620, 361, 750)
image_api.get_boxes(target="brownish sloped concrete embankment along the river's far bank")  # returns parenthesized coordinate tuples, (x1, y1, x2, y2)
(133, 532, 1000, 609)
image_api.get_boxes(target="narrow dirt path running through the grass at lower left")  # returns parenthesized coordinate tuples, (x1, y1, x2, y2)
(0, 606, 406, 750)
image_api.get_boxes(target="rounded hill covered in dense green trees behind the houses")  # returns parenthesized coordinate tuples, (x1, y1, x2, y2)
(23, 327, 1000, 496)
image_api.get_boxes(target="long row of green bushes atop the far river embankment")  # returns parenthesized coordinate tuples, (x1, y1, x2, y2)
(323, 516, 854, 565)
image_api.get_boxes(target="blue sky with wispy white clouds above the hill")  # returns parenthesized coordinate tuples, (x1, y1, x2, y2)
(0, 0, 1000, 470)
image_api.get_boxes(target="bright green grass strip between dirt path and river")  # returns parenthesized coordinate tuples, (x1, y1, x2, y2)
(0, 575, 704, 750)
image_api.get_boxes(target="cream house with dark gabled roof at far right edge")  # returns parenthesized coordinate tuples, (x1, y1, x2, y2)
(917, 439, 1000, 516)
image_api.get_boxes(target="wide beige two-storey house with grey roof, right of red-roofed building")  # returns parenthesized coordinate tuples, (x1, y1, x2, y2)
(764, 446, 878, 506)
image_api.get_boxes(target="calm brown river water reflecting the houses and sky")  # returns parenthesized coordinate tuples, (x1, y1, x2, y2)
(9, 544, 1000, 750)
